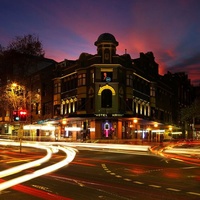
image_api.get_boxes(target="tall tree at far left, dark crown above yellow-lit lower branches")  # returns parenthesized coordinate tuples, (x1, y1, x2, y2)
(0, 34, 44, 121)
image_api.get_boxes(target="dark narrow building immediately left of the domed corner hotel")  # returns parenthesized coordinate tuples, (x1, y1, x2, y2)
(26, 59, 56, 124)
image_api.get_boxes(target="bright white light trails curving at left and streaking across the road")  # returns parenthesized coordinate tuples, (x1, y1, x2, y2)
(0, 141, 199, 191)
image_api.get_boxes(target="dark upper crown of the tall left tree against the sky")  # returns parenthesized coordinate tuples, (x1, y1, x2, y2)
(0, 34, 44, 85)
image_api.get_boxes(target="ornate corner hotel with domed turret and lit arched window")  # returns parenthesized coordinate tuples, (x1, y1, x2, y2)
(53, 33, 173, 141)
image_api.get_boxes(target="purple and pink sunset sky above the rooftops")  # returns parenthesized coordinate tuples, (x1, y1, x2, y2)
(0, 0, 200, 86)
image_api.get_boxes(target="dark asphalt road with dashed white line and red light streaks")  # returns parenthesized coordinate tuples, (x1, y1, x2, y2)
(0, 145, 200, 200)
